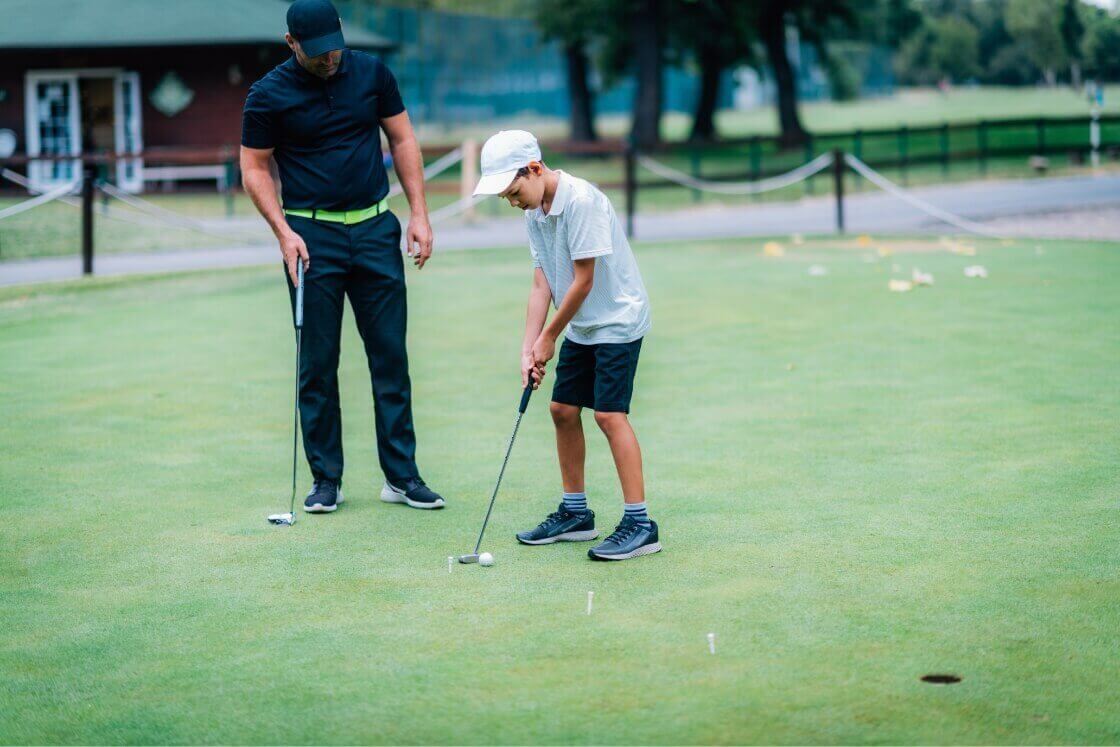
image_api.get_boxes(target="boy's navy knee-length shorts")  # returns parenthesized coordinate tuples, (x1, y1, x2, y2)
(552, 338, 642, 412)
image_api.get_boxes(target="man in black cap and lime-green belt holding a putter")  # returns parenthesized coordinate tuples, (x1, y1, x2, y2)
(241, 0, 444, 513)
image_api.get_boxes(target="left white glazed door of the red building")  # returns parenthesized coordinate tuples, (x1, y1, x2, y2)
(25, 73, 82, 190)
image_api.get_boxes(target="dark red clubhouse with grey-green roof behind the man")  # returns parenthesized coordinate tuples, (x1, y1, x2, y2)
(0, 0, 393, 192)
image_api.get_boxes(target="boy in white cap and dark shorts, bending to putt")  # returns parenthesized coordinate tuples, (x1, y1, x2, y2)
(475, 130, 661, 560)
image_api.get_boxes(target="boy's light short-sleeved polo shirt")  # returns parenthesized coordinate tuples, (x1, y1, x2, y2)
(525, 171, 650, 345)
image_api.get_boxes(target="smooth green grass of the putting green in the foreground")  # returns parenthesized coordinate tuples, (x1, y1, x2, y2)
(0, 239, 1120, 744)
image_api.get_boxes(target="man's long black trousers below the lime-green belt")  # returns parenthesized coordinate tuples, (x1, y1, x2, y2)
(284, 213, 419, 483)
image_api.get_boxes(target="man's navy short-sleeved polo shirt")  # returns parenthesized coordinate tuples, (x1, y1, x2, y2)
(241, 49, 404, 211)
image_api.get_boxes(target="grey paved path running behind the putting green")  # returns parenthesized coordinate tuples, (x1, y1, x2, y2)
(0, 174, 1120, 286)
